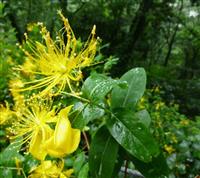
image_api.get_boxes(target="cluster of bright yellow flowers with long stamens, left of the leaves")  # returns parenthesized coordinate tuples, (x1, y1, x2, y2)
(0, 11, 97, 178)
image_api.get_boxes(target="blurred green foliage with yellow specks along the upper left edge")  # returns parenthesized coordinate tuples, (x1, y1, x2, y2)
(0, 3, 22, 100)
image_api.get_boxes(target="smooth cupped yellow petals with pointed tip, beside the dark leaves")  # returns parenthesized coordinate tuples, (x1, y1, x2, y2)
(45, 106, 80, 157)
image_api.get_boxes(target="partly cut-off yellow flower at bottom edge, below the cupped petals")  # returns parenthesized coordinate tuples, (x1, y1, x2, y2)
(28, 160, 74, 178)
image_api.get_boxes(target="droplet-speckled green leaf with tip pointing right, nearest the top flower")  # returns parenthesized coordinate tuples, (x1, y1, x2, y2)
(82, 73, 123, 101)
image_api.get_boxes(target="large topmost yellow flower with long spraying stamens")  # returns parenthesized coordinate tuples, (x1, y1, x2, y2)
(16, 11, 97, 96)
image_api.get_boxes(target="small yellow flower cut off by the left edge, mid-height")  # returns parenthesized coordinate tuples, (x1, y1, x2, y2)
(0, 102, 13, 125)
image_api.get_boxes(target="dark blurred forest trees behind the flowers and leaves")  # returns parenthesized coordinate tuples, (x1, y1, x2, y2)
(2, 0, 200, 115)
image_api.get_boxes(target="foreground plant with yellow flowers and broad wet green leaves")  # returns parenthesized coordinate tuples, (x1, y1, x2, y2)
(0, 12, 162, 177)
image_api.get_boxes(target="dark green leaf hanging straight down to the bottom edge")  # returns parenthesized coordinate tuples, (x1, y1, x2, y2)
(89, 127, 118, 178)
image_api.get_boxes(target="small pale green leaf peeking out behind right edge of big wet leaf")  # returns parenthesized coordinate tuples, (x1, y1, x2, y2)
(135, 109, 151, 128)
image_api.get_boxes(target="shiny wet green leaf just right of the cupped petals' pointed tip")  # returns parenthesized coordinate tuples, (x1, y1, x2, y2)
(70, 102, 104, 130)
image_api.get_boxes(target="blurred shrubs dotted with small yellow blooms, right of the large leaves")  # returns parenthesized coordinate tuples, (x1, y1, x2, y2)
(138, 87, 200, 177)
